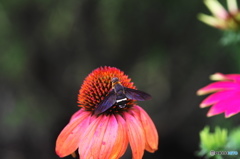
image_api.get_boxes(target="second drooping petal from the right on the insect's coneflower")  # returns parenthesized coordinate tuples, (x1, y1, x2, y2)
(123, 112, 145, 159)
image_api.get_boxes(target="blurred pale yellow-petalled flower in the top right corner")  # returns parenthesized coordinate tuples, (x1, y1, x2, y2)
(198, 0, 240, 30)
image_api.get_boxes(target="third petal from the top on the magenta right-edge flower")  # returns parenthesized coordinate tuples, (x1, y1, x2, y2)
(200, 90, 238, 108)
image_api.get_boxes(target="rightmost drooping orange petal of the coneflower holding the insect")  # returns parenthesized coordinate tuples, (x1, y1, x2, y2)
(134, 105, 158, 153)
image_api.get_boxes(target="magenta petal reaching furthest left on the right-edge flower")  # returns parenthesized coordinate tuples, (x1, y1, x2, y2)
(197, 81, 240, 95)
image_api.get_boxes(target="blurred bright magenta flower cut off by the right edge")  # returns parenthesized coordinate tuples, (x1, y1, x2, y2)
(197, 73, 240, 118)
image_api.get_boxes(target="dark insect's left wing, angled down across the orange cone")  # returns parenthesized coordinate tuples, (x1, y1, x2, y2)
(95, 90, 117, 115)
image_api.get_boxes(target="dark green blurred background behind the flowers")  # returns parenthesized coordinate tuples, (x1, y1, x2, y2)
(0, 0, 239, 159)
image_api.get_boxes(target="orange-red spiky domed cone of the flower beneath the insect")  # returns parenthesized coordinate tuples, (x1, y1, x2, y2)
(78, 66, 136, 114)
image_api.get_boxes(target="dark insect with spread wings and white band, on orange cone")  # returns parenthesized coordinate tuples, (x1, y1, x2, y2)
(95, 77, 152, 115)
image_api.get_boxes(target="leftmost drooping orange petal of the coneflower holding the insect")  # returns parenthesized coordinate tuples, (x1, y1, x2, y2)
(55, 110, 90, 157)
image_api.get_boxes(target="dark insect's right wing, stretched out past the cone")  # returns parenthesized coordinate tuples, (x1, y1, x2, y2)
(124, 88, 152, 101)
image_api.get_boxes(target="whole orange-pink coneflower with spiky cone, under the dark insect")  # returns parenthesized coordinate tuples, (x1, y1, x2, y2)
(55, 67, 158, 159)
